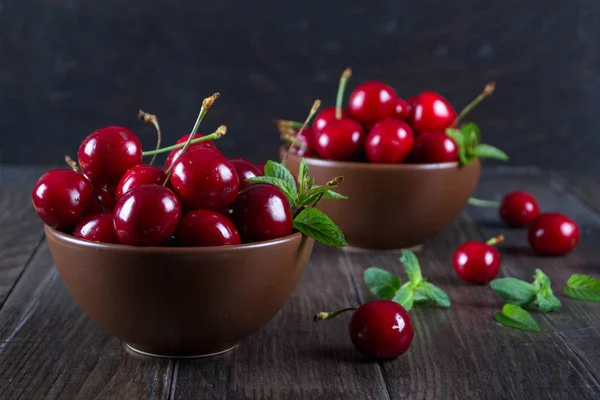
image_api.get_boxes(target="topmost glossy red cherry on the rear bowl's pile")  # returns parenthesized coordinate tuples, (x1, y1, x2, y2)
(348, 81, 398, 127)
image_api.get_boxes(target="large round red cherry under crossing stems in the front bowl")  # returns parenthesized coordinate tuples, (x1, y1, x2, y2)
(171, 147, 240, 211)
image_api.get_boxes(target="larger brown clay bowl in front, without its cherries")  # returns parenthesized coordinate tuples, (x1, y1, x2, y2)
(45, 226, 314, 357)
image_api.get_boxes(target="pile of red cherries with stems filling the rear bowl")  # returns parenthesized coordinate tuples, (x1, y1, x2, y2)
(277, 68, 493, 164)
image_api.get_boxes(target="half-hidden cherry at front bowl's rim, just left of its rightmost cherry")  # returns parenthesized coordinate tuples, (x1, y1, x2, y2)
(177, 210, 241, 246)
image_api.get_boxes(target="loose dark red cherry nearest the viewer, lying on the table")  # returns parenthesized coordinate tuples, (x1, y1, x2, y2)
(349, 300, 414, 360)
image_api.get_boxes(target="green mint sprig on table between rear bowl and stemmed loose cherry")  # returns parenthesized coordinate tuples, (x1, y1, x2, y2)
(364, 250, 451, 311)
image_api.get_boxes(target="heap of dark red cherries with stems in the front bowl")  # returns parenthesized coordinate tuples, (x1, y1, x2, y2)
(32, 94, 293, 246)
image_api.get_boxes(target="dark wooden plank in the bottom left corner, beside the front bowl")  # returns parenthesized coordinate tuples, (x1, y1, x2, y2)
(0, 243, 173, 400)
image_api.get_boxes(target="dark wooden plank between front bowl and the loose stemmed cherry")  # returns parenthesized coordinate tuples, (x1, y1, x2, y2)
(173, 245, 388, 400)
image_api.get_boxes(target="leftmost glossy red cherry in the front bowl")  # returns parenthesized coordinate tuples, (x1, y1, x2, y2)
(31, 169, 97, 231)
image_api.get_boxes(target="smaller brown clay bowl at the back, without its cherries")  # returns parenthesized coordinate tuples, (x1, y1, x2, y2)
(280, 148, 481, 250)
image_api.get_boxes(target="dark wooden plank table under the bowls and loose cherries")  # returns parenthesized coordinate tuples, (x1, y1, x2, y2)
(0, 166, 600, 399)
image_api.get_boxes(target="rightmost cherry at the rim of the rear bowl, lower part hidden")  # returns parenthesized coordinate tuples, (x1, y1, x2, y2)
(409, 131, 458, 164)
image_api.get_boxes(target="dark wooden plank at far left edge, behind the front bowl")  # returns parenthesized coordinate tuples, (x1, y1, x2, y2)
(0, 165, 45, 307)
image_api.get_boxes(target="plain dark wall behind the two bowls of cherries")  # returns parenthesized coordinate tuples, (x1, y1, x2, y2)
(0, 0, 600, 171)
